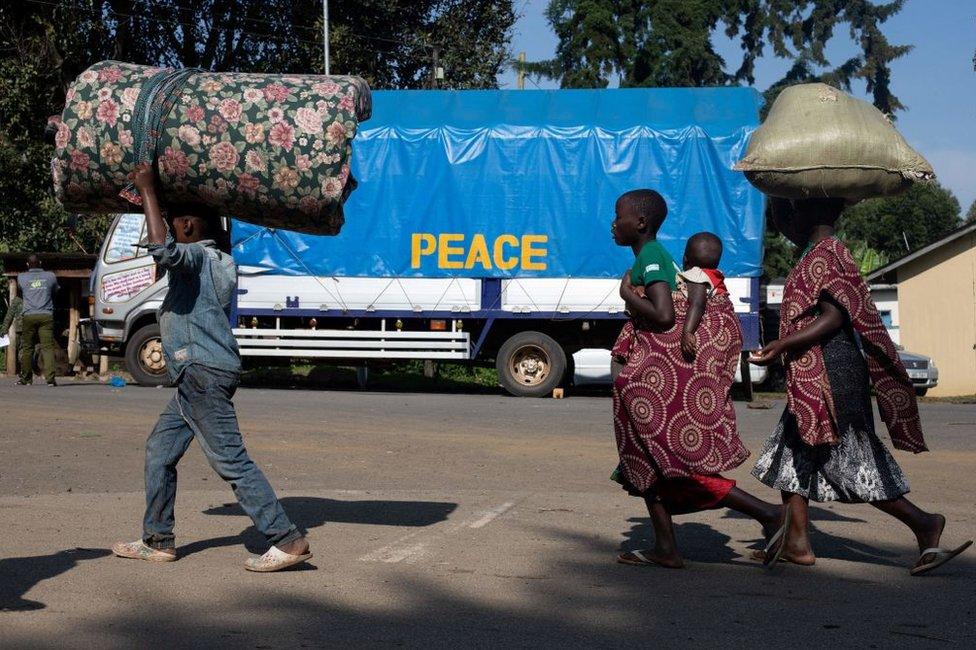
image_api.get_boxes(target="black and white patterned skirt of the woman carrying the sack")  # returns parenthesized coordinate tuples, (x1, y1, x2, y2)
(752, 327, 908, 503)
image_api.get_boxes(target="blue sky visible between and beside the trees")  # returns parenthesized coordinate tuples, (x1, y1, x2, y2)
(498, 0, 976, 214)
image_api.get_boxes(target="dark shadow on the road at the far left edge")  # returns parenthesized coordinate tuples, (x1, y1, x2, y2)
(0, 548, 111, 612)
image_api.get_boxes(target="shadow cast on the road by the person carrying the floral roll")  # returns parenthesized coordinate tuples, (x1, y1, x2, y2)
(179, 497, 457, 557)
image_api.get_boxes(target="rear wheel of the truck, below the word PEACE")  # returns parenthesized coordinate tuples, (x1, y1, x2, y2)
(495, 332, 566, 397)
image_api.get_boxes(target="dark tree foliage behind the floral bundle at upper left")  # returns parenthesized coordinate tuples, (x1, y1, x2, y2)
(0, 0, 515, 251)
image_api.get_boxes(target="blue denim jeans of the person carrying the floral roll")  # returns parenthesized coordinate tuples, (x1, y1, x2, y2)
(143, 364, 301, 548)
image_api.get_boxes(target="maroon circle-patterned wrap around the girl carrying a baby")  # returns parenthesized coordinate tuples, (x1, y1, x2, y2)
(613, 292, 749, 492)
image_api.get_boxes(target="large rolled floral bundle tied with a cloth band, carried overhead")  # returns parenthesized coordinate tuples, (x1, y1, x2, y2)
(52, 61, 371, 235)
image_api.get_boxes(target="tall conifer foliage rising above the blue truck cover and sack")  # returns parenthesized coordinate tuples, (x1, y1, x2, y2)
(525, 0, 911, 114)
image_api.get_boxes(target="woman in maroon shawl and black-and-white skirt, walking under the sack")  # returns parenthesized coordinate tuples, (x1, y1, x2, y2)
(750, 199, 972, 575)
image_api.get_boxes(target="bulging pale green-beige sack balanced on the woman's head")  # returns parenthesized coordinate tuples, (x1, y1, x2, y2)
(735, 83, 935, 199)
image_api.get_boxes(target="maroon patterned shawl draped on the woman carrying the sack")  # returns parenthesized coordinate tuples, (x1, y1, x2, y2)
(779, 237, 927, 453)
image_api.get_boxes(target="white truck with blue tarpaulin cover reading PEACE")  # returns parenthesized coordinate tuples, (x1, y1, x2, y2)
(82, 88, 764, 396)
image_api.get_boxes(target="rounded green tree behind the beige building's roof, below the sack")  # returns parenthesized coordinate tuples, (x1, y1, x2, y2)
(838, 183, 961, 259)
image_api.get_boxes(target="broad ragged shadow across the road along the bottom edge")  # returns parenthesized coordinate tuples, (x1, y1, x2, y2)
(0, 519, 976, 650)
